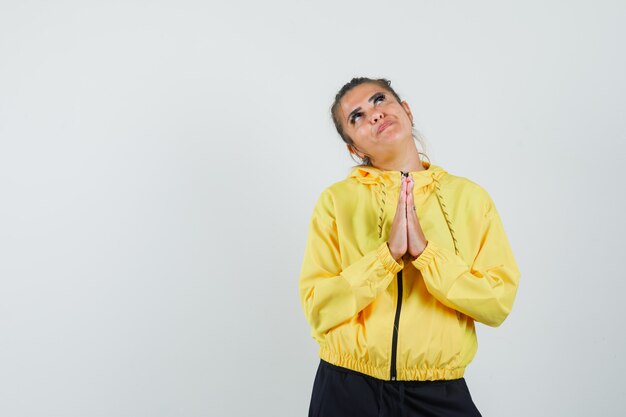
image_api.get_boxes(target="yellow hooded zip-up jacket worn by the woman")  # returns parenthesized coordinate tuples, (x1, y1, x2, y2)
(299, 161, 520, 381)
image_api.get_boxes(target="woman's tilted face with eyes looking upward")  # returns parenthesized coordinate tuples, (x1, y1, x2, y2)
(339, 83, 413, 162)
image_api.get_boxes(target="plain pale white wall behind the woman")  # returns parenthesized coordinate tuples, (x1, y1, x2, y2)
(0, 0, 626, 417)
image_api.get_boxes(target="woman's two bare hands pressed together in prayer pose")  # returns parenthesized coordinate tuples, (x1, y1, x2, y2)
(387, 175, 428, 261)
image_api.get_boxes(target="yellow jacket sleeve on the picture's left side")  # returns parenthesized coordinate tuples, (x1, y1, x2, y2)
(299, 192, 403, 341)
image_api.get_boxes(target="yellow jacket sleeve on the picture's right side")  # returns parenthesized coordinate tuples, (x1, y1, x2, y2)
(412, 191, 520, 327)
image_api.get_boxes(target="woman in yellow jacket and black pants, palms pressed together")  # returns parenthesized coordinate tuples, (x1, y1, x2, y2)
(299, 78, 520, 417)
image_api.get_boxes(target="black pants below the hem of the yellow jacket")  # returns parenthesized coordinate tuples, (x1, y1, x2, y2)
(309, 360, 481, 417)
